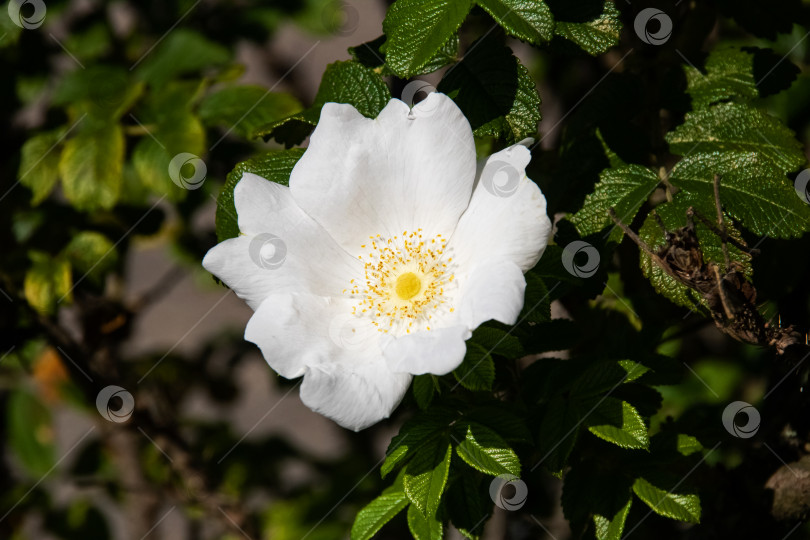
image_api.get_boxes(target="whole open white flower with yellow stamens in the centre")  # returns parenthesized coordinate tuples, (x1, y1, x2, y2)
(203, 93, 551, 430)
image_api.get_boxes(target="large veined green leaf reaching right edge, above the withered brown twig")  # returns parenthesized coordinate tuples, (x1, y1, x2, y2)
(670, 151, 810, 238)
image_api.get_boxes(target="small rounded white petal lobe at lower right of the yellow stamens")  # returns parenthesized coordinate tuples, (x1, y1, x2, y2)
(455, 260, 526, 330)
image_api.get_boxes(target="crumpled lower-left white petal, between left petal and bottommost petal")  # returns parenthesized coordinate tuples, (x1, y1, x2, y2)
(245, 294, 382, 378)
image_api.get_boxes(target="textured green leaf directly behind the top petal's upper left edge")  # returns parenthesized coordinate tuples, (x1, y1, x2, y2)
(253, 61, 391, 148)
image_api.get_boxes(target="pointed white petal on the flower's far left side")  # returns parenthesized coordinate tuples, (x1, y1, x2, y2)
(203, 173, 362, 310)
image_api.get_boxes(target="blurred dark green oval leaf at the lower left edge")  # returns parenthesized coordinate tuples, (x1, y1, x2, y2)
(6, 389, 56, 478)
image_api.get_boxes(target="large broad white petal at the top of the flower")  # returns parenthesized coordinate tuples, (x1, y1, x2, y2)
(290, 93, 475, 254)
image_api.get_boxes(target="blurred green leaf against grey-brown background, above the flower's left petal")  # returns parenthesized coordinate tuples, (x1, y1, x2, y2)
(199, 85, 302, 137)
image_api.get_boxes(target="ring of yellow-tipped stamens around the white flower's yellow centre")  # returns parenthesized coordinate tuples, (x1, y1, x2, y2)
(344, 229, 455, 335)
